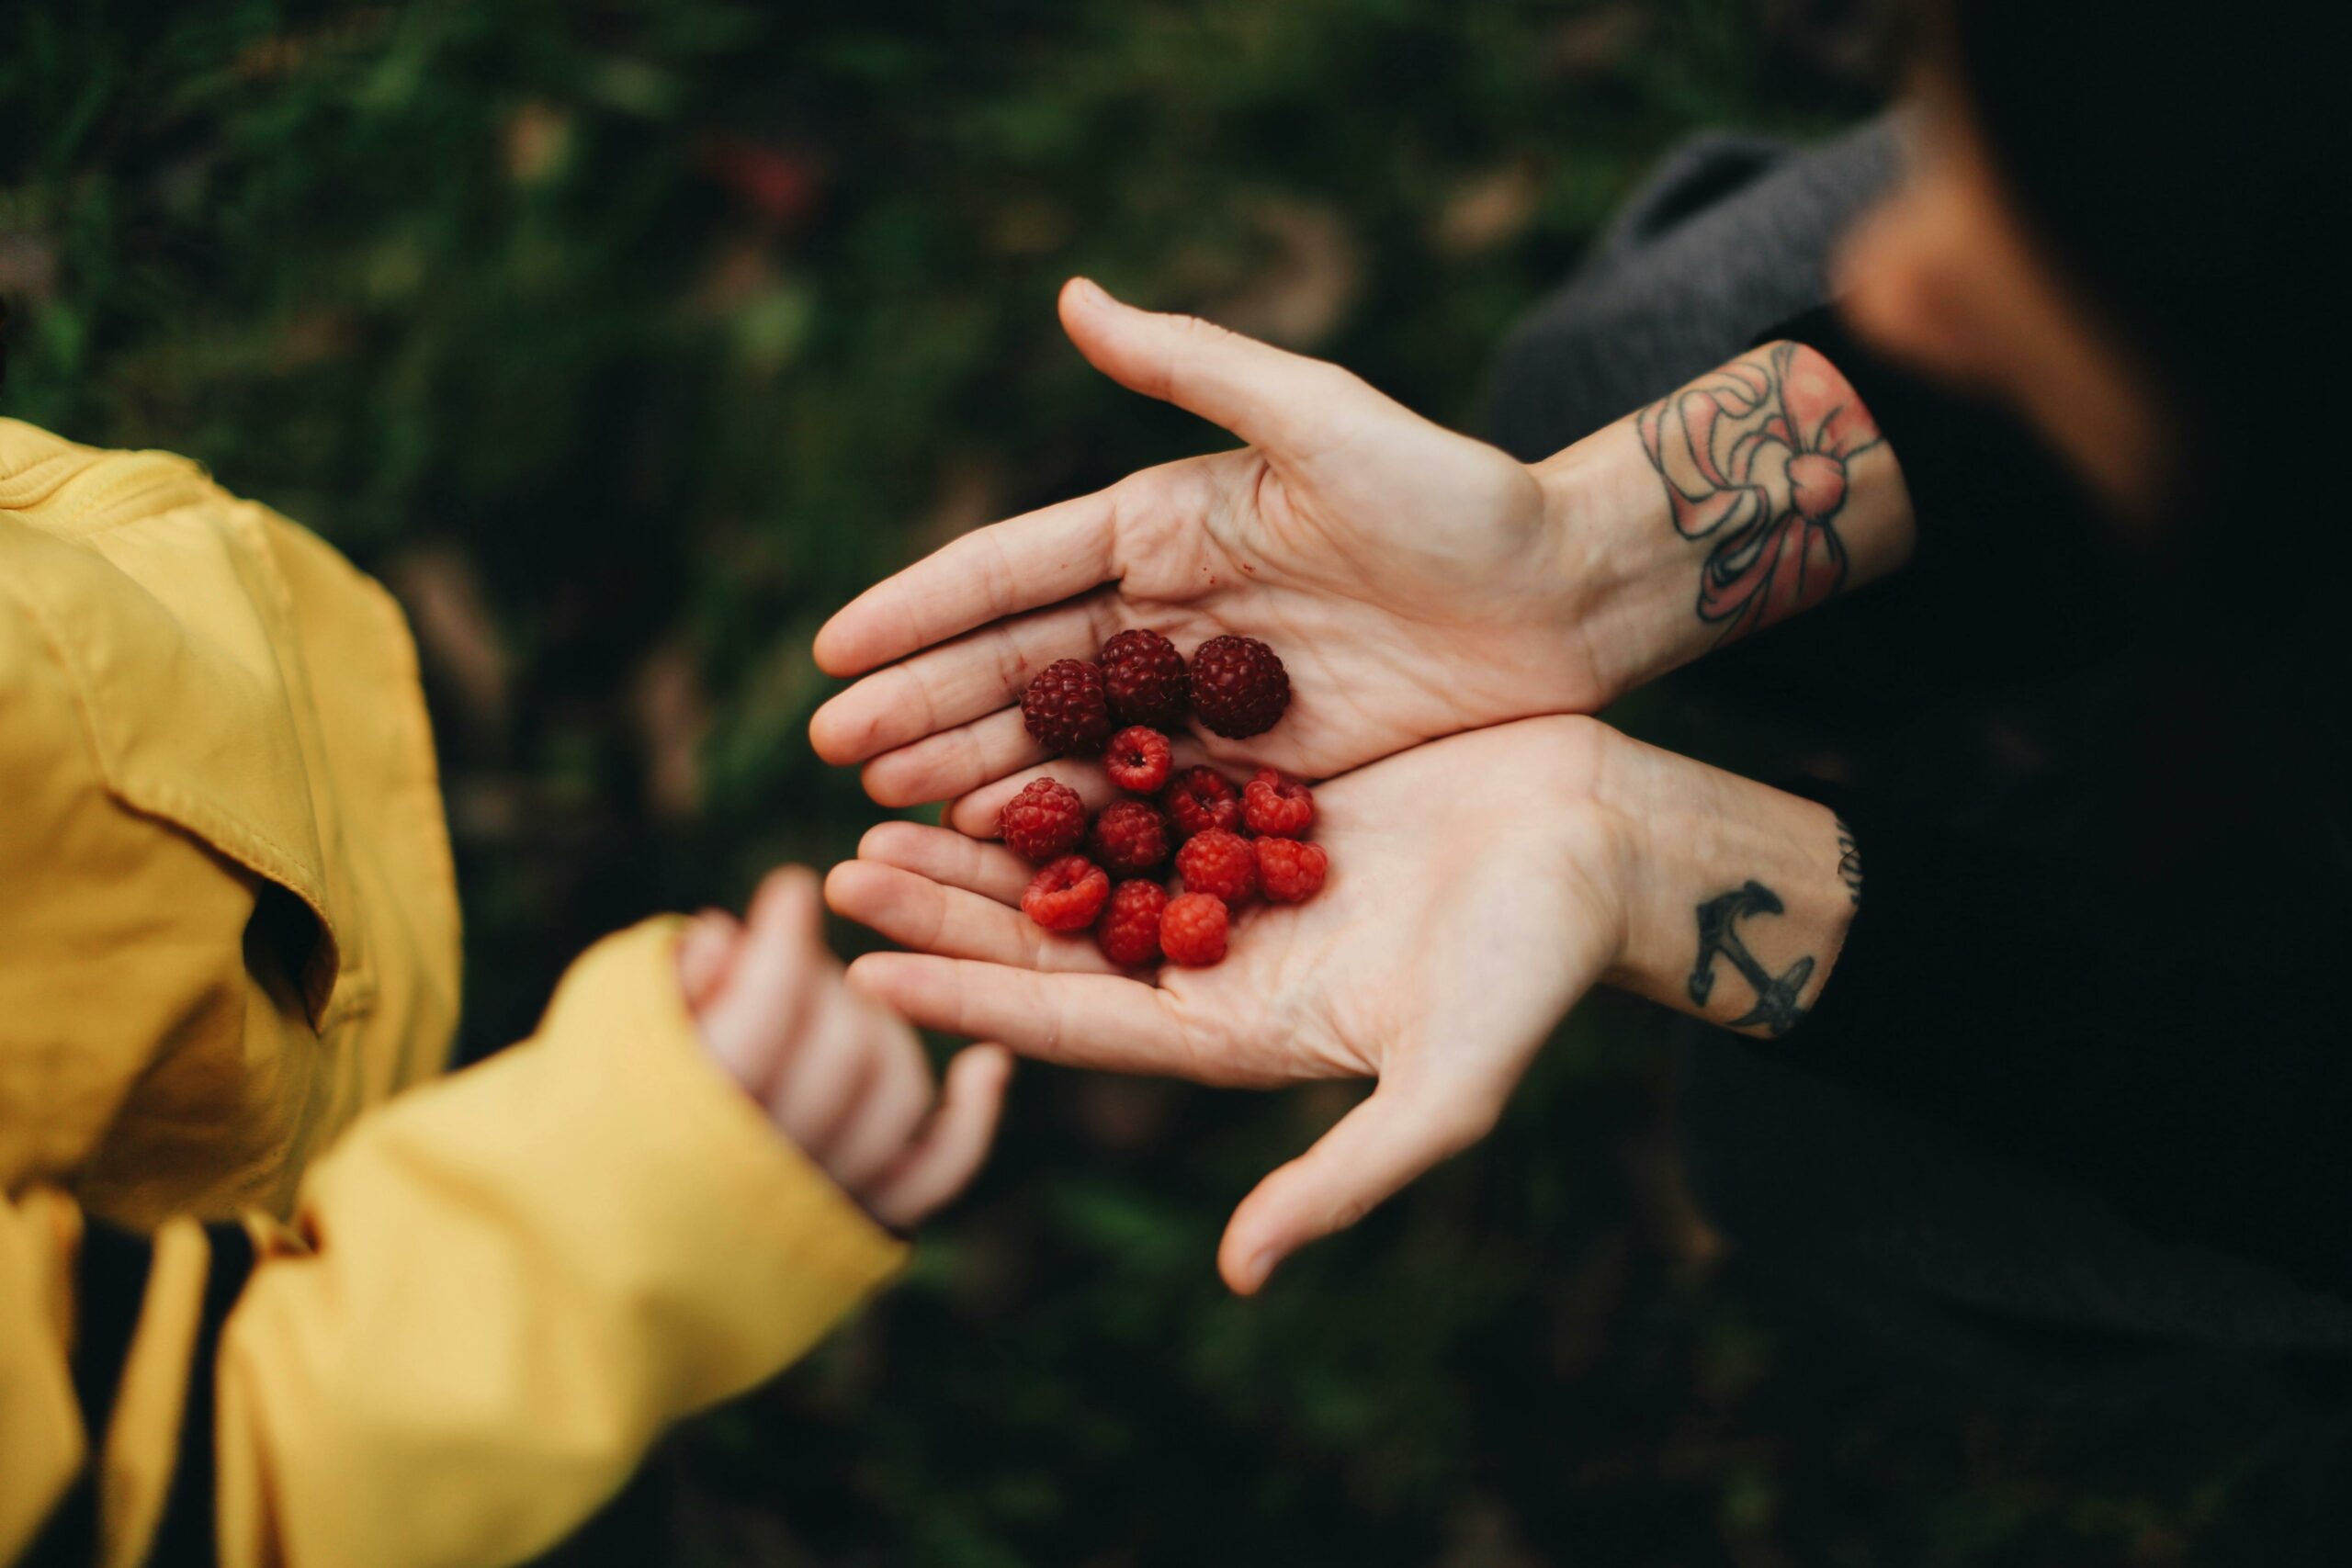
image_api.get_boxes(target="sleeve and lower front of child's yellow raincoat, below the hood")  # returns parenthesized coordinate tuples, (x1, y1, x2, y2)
(0, 921, 903, 1568)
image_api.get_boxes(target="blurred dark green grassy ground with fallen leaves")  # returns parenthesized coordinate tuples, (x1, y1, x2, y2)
(0, 0, 2352, 1568)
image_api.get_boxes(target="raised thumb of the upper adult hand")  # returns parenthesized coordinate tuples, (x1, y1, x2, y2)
(1061, 277, 1387, 458)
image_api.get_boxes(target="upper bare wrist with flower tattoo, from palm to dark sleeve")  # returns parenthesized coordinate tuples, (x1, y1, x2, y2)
(1533, 341, 1915, 698)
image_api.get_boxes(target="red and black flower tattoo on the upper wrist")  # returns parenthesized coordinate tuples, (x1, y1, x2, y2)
(1634, 344, 1879, 642)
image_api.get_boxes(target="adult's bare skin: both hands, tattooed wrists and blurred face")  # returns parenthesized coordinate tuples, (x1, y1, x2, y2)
(811, 98, 2166, 1293)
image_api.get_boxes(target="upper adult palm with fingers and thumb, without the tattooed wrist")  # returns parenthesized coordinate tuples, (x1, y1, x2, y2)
(811, 282, 1601, 807)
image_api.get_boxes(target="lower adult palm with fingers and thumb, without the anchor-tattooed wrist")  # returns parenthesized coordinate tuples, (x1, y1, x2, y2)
(826, 719, 1625, 1293)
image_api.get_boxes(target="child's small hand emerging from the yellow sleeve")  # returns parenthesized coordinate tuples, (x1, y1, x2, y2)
(677, 867, 1012, 1229)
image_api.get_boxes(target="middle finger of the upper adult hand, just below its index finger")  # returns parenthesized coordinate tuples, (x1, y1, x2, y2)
(809, 594, 1110, 766)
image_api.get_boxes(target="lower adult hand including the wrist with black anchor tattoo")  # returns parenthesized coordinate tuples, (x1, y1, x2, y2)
(826, 717, 1860, 1293)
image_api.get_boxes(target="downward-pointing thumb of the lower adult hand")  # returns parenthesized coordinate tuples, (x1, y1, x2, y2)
(1216, 1086, 1494, 1295)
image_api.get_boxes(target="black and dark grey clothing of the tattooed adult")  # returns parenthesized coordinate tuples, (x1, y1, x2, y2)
(1491, 127, 2352, 1375)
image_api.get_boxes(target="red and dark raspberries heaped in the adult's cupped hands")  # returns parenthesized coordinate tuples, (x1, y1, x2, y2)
(997, 630, 1331, 968)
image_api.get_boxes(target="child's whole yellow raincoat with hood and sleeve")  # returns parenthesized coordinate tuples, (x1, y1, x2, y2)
(0, 421, 900, 1568)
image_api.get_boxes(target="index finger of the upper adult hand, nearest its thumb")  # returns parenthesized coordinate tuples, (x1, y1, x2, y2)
(814, 489, 1117, 674)
